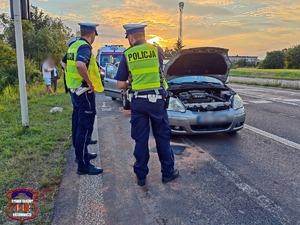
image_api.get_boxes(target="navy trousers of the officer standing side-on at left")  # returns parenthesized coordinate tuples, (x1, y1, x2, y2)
(71, 92, 96, 169)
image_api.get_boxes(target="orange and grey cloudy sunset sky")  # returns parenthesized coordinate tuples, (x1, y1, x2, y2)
(0, 0, 300, 58)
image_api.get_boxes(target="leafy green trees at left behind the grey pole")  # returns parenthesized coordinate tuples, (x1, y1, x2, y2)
(0, 6, 71, 94)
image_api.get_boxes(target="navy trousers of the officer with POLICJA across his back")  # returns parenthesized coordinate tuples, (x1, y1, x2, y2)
(131, 93, 174, 179)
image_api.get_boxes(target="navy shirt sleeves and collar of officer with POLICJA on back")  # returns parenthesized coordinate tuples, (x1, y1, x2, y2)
(115, 40, 164, 81)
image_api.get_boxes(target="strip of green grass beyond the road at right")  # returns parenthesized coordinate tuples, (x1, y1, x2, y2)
(230, 68, 300, 80)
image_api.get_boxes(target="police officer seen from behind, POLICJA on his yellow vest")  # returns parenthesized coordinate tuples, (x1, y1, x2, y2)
(115, 24, 179, 186)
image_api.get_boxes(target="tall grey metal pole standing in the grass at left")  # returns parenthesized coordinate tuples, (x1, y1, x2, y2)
(13, 0, 29, 127)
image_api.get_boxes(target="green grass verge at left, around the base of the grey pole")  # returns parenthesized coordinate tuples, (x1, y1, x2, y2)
(0, 80, 72, 225)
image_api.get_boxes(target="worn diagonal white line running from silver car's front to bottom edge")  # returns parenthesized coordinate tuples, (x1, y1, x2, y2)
(182, 138, 289, 224)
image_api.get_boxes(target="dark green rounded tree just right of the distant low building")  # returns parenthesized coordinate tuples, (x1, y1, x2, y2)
(259, 51, 285, 69)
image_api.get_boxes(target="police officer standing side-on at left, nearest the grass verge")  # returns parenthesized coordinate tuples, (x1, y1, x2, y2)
(63, 23, 104, 175)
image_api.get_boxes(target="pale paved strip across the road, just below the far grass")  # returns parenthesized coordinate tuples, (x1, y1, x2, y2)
(229, 77, 300, 89)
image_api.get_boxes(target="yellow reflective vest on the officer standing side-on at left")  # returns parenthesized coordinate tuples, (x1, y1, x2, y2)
(66, 40, 104, 92)
